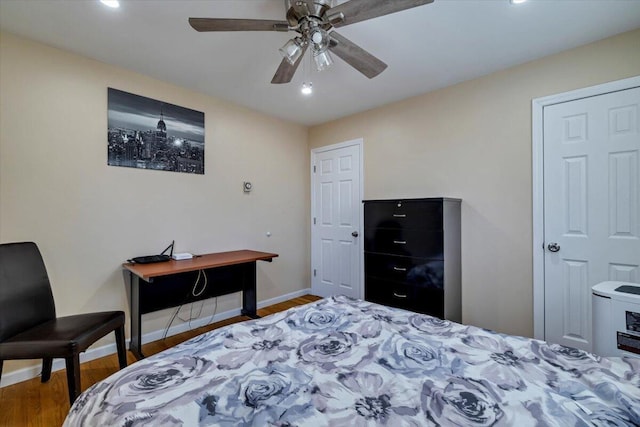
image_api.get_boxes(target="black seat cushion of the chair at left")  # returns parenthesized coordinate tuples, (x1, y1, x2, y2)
(0, 311, 124, 360)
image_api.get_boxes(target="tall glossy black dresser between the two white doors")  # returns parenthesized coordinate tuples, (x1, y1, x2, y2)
(364, 198, 462, 322)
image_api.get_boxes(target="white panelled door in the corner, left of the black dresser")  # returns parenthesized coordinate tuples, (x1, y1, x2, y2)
(311, 140, 362, 298)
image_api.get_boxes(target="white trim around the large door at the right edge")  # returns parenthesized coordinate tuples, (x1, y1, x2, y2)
(532, 76, 640, 340)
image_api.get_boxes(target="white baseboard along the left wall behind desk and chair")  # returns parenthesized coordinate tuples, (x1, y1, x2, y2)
(0, 288, 311, 388)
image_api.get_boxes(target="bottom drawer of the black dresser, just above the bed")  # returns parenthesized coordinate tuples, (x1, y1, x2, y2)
(365, 276, 444, 319)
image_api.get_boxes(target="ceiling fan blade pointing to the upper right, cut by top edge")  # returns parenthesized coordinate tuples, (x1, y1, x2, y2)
(326, 0, 433, 27)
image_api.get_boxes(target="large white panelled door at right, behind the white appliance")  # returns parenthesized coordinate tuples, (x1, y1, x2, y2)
(543, 88, 640, 351)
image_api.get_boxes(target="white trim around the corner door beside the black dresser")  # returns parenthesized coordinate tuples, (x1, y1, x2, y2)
(309, 138, 364, 299)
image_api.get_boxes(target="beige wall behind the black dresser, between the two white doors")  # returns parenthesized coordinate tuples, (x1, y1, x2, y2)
(309, 30, 640, 336)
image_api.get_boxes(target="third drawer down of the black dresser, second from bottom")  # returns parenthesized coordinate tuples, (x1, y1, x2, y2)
(364, 253, 444, 289)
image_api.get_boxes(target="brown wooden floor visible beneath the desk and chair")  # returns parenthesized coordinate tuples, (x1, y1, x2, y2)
(0, 295, 320, 427)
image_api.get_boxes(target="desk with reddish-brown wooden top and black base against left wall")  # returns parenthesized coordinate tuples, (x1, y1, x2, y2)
(123, 250, 278, 359)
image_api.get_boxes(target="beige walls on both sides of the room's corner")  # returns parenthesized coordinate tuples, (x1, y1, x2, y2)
(0, 30, 640, 382)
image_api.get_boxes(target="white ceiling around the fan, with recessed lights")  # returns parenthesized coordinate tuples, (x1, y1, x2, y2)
(0, 0, 640, 125)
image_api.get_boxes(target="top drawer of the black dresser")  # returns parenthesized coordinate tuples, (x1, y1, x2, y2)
(364, 200, 442, 230)
